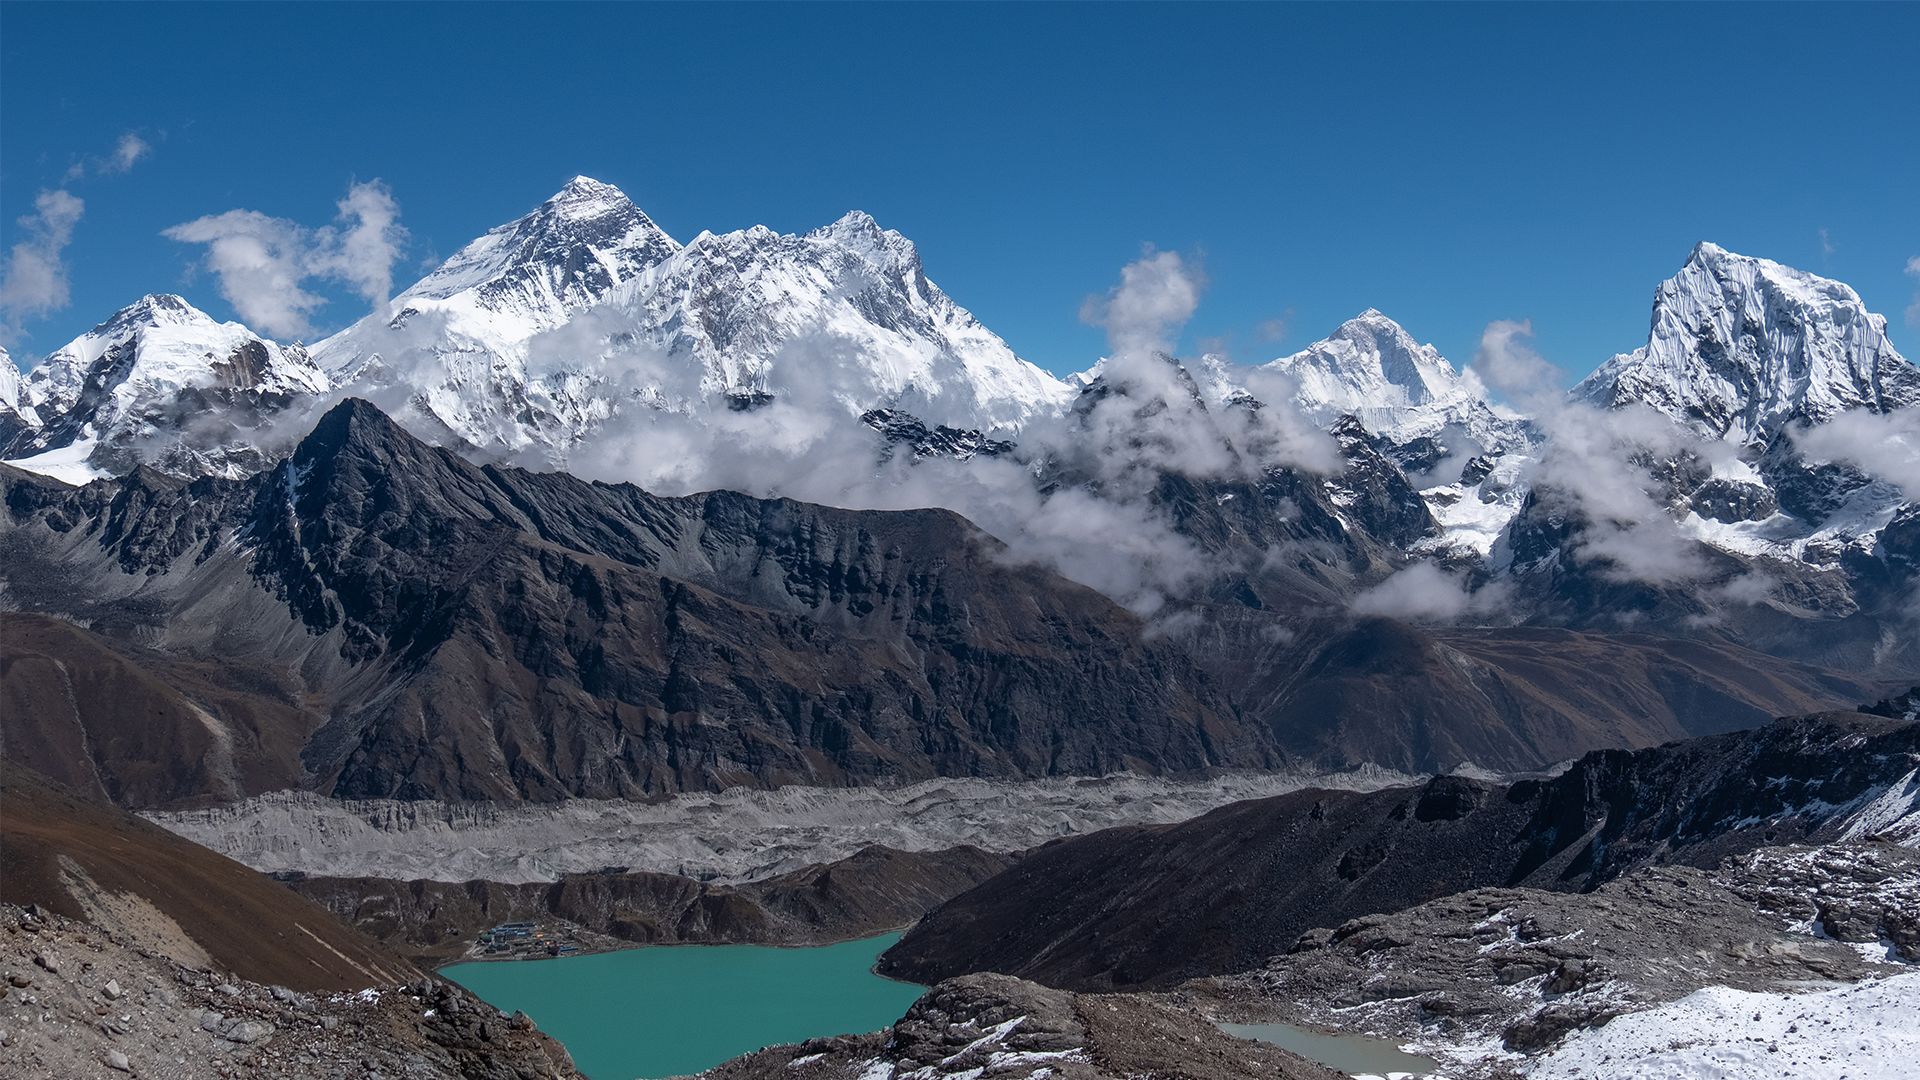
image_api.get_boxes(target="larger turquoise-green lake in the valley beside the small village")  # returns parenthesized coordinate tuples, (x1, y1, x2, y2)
(451, 934, 925, 1080)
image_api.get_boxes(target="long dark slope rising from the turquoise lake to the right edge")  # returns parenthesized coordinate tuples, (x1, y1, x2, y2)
(881, 713, 1920, 988)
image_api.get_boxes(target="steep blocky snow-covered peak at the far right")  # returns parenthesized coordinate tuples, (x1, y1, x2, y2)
(1572, 242, 1920, 446)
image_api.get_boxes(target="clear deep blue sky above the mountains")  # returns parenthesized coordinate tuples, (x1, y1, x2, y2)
(0, 2, 1920, 379)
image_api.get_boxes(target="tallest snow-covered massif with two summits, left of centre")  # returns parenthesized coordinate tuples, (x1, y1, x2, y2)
(313, 177, 1068, 463)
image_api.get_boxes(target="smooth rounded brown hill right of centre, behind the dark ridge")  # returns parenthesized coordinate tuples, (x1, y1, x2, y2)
(1194, 611, 1870, 773)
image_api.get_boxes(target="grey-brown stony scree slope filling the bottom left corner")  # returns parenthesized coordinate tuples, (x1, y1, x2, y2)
(0, 905, 578, 1080)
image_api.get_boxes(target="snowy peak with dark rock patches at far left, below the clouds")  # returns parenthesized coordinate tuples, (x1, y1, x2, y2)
(0, 294, 328, 482)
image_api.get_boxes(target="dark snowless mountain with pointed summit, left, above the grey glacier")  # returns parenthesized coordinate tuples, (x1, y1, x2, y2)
(0, 402, 1281, 805)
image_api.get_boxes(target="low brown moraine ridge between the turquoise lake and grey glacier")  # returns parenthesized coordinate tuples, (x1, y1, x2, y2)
(286, 847, 1014, 959)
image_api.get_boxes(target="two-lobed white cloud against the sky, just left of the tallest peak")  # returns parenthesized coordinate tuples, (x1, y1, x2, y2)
(161, 181, 407, 338)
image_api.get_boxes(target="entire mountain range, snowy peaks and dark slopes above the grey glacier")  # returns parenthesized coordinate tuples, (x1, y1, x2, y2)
(0, 177, 1920, 805)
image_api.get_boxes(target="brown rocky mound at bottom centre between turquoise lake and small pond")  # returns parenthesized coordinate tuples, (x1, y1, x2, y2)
(703, 974, 1342, 1080)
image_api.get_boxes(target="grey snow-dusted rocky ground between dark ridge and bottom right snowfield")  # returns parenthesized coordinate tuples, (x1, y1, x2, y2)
(1198, 844, 1920, 1053)
